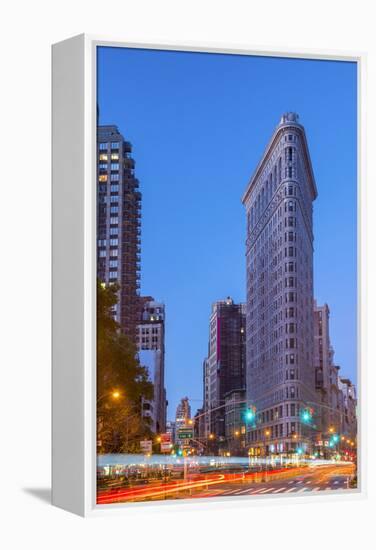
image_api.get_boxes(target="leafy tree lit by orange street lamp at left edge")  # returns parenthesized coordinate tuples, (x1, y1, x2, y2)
(97, 282, 154, 453)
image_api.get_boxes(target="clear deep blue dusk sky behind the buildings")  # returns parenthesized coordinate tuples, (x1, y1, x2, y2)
(98, 47, 357, 418)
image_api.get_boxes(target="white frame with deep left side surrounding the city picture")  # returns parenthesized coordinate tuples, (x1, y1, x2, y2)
(52, 34, 367, 516)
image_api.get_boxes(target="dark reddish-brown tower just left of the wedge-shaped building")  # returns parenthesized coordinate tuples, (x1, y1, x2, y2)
(203, 297, 246, 443)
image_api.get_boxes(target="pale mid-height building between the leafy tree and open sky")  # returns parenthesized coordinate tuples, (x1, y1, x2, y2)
(136, 296, 167, 433)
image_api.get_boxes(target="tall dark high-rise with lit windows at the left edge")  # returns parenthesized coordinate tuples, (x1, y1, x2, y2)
(97, 126, 141, 341)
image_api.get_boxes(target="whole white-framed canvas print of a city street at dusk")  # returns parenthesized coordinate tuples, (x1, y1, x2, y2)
(53, 35, 365, 515)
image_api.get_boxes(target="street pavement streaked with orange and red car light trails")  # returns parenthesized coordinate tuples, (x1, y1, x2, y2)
(97, 463, 355, 504)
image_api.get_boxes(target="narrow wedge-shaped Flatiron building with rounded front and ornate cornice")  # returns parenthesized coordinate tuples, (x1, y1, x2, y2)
(242, 113, 317, 454)
